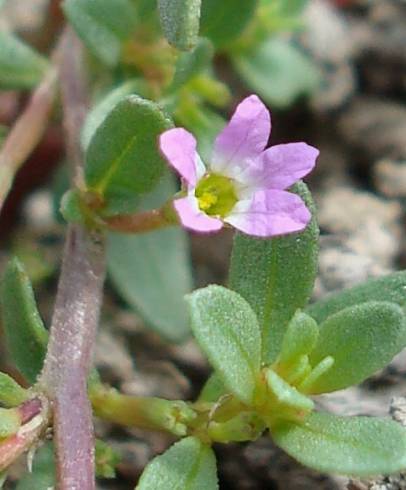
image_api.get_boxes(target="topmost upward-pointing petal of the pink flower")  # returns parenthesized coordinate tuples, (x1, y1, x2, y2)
(210, 95, 271, 177)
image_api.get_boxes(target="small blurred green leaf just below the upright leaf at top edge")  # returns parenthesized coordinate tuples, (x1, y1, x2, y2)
(169, 39, 214, 90)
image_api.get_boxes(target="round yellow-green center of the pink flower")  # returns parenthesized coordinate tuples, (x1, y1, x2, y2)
(195, 174, 238, 218)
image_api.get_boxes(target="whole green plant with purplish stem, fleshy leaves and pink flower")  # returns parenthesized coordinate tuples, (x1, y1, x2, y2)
(0, 0, 406, 490)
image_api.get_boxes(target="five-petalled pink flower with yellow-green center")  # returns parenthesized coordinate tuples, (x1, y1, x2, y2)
(160, 95, 319, 237)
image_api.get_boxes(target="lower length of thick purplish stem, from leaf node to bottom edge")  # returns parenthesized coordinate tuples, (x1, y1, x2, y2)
(40, 225, 105, 490)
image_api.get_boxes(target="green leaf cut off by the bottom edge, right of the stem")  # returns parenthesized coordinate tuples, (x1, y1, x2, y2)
(136, 437, 218, 490)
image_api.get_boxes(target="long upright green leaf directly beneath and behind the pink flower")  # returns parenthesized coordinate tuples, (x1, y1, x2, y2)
(230, 182, 319, 364)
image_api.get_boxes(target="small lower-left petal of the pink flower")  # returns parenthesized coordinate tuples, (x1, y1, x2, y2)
(173, 196, 223, 233)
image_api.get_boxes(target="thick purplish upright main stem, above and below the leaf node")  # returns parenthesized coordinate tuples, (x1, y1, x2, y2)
(39, 28, 105, 490)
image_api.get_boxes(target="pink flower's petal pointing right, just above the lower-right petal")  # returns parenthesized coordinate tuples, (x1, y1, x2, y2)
(244, 143, 319, 189)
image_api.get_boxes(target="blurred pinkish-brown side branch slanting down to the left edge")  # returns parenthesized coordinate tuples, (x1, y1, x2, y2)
(0, 67, 58, 211)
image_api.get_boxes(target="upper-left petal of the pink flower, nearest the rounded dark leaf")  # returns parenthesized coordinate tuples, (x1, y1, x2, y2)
(159, 128, 205, 186)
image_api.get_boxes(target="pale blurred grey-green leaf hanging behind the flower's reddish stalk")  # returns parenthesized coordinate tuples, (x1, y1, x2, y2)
(107, 174, 193, 342)
